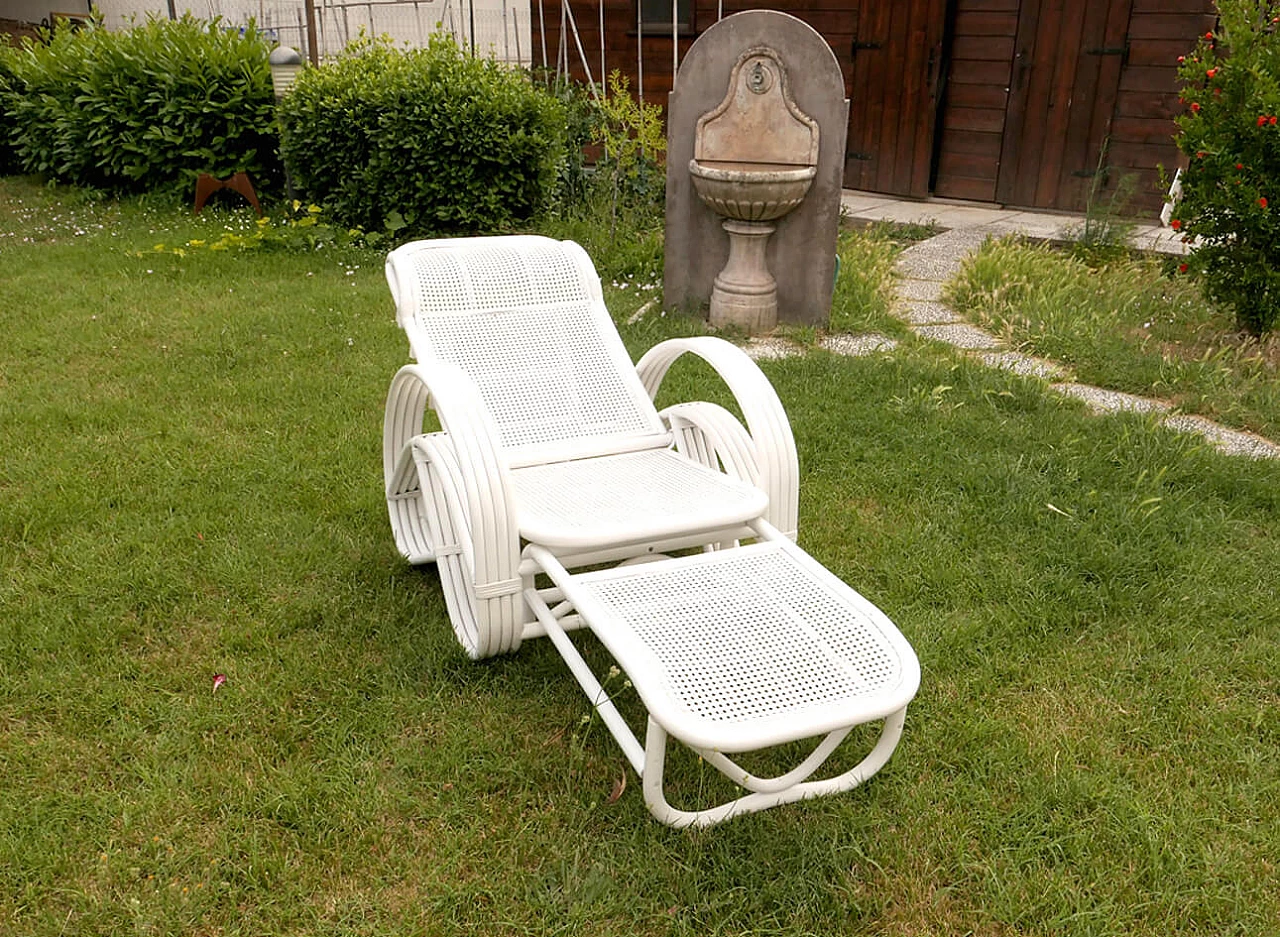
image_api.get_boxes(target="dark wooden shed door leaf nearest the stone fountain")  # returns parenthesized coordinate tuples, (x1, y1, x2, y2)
(836, 0, 946, 197)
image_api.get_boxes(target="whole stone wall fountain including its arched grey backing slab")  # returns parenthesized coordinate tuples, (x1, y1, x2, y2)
(663, 10, 849, 332)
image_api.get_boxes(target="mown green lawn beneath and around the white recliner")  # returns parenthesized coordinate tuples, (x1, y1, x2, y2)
(0, 180, 1280, 937)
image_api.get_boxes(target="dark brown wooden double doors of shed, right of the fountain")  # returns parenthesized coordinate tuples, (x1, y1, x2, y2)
(837, 0, 1133, 210)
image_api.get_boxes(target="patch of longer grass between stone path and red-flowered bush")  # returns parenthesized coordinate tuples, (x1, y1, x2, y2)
(946, 234, 1280, 438)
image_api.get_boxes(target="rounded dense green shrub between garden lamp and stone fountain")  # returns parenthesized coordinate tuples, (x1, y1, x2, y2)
(280, 36, 564, 233)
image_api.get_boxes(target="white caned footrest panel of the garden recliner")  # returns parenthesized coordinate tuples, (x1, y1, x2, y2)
(567, 543, 920, 751)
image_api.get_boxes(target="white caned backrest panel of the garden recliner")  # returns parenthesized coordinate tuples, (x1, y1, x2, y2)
(387, 236, 664, 463)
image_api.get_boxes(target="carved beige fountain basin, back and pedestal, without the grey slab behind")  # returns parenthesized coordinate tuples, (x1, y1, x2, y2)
(689, 46, 818, 333)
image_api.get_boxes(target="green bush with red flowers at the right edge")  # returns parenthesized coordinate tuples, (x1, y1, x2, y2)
(1171, 0, 1280, 334)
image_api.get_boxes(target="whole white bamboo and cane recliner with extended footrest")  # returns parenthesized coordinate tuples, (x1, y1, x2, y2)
(384, 236, 919, 826)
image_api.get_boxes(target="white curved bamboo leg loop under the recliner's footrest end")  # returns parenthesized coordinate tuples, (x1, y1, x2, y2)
(641, 707, 906, 827)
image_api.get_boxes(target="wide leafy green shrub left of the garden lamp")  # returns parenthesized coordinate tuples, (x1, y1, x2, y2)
(10, 15, 278, 191)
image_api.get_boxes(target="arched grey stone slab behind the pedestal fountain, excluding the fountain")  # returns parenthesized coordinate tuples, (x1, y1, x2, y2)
(663, 10, 849, 326)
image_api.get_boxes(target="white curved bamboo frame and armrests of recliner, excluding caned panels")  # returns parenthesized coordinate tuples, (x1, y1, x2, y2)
(383, 235, 918, 827)
